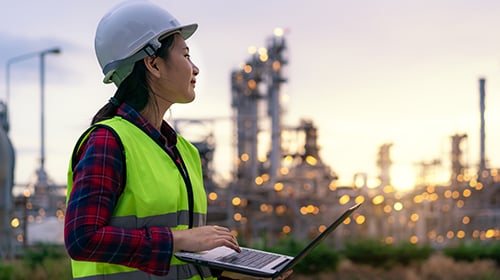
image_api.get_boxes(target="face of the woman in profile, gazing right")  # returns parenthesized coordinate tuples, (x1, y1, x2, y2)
(155, 34, 200, 105)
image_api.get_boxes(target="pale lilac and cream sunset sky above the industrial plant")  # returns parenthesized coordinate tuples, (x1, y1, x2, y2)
(0, 0, 500, 191)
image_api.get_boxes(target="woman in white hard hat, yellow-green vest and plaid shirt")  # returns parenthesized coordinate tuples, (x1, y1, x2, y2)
(64, 1, 240, 280)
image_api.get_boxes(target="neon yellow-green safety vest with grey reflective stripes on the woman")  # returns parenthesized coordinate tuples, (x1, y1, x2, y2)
(68, 117, 215, 280)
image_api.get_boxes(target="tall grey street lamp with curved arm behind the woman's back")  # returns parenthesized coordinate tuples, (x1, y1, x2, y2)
(5, 48, 61, 186)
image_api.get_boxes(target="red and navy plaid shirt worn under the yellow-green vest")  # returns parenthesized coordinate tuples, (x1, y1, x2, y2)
(64, 104, 184, 275)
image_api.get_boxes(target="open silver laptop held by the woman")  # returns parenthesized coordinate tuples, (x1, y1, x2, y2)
(174, 203, 361, 278)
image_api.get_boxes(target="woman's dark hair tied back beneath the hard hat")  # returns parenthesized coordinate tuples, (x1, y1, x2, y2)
(91, 35, 174, 124)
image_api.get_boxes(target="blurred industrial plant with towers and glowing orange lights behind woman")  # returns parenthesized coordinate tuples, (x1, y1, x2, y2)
(0, 29, 500, 257)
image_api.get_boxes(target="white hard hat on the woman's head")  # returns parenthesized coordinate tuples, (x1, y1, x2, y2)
(94, 1, 198, 86)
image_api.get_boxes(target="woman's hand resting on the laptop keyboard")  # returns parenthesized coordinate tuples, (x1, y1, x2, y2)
(172, 226, 241, 253)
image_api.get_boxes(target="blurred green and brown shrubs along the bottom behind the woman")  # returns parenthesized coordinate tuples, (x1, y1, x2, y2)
(0, 239, 500, 280)
